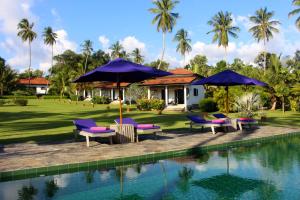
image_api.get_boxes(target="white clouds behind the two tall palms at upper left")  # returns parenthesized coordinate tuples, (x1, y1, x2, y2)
(0, 0, 77, 71)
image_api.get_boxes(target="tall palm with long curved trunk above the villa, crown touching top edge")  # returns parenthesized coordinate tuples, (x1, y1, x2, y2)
(149, 0, 179, 69)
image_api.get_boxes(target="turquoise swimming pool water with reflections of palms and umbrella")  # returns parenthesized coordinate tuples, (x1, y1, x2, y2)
(0, 137, 300, 200)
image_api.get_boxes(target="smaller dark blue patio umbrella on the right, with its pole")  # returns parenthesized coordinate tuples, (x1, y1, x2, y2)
(193, 70, 267, 115)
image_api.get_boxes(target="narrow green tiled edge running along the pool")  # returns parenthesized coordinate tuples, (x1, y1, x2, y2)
(0, 132, 300, 182)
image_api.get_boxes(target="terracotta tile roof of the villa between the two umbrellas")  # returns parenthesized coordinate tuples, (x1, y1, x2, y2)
(142, 68, 200, 85)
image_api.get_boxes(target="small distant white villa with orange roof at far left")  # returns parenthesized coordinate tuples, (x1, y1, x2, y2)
(18, 77, 50, 94)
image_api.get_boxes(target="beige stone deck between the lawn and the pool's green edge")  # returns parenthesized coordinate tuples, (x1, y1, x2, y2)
(0, 126, 300, 172)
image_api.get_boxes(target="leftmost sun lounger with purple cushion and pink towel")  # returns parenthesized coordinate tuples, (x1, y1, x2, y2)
(73, 119, 116, 147)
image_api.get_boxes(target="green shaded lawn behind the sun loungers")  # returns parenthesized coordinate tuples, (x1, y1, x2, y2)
(0, 99, 300, 144)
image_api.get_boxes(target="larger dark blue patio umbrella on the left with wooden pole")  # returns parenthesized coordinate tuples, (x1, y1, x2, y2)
(74, 58, 172, 124)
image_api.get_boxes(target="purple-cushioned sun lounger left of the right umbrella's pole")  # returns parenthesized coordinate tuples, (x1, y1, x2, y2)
(187, 115, 231, 134)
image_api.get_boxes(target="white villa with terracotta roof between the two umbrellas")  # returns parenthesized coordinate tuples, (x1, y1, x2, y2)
(141, 68, 204, 110)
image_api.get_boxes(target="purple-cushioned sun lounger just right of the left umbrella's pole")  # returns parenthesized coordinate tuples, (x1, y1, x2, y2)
(115, 118, 162, 142)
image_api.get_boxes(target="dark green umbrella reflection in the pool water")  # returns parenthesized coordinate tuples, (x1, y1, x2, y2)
(193, 174, 268, 199)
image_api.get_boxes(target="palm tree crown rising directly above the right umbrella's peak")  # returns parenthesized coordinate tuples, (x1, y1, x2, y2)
(207, 11, 240, 63)
